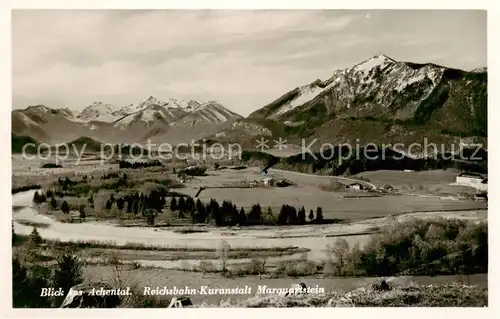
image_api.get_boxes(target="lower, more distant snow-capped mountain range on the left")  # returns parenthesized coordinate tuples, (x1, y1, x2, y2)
(12, 96, 242, 144)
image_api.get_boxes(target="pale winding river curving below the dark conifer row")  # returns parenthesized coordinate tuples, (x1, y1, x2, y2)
(12, 190, 488, 268)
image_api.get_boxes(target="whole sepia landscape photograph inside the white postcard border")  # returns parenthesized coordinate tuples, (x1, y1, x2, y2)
(2, 4, 495, 316)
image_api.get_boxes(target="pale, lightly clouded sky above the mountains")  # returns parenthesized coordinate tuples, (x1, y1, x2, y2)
(12, 10, 487, 116)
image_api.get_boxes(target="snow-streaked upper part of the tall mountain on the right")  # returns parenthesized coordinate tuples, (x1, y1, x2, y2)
(251, 55, 462, 120)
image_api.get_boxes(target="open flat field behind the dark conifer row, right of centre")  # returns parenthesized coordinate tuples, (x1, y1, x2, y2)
(175, 168, 486, 220)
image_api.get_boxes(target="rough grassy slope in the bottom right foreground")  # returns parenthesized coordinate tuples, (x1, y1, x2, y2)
(200, 283, 488, 308)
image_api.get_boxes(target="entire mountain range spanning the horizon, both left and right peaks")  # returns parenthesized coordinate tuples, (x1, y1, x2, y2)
(12, 55, 487, 150)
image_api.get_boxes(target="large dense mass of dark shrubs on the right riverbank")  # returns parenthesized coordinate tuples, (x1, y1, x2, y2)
(324, 219, 488, 276)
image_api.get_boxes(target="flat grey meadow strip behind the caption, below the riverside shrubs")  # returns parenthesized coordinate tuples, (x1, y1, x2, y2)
(85, 266, 488, 305)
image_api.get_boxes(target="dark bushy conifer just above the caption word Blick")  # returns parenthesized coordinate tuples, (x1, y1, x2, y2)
(52, 253, 83, 303)
